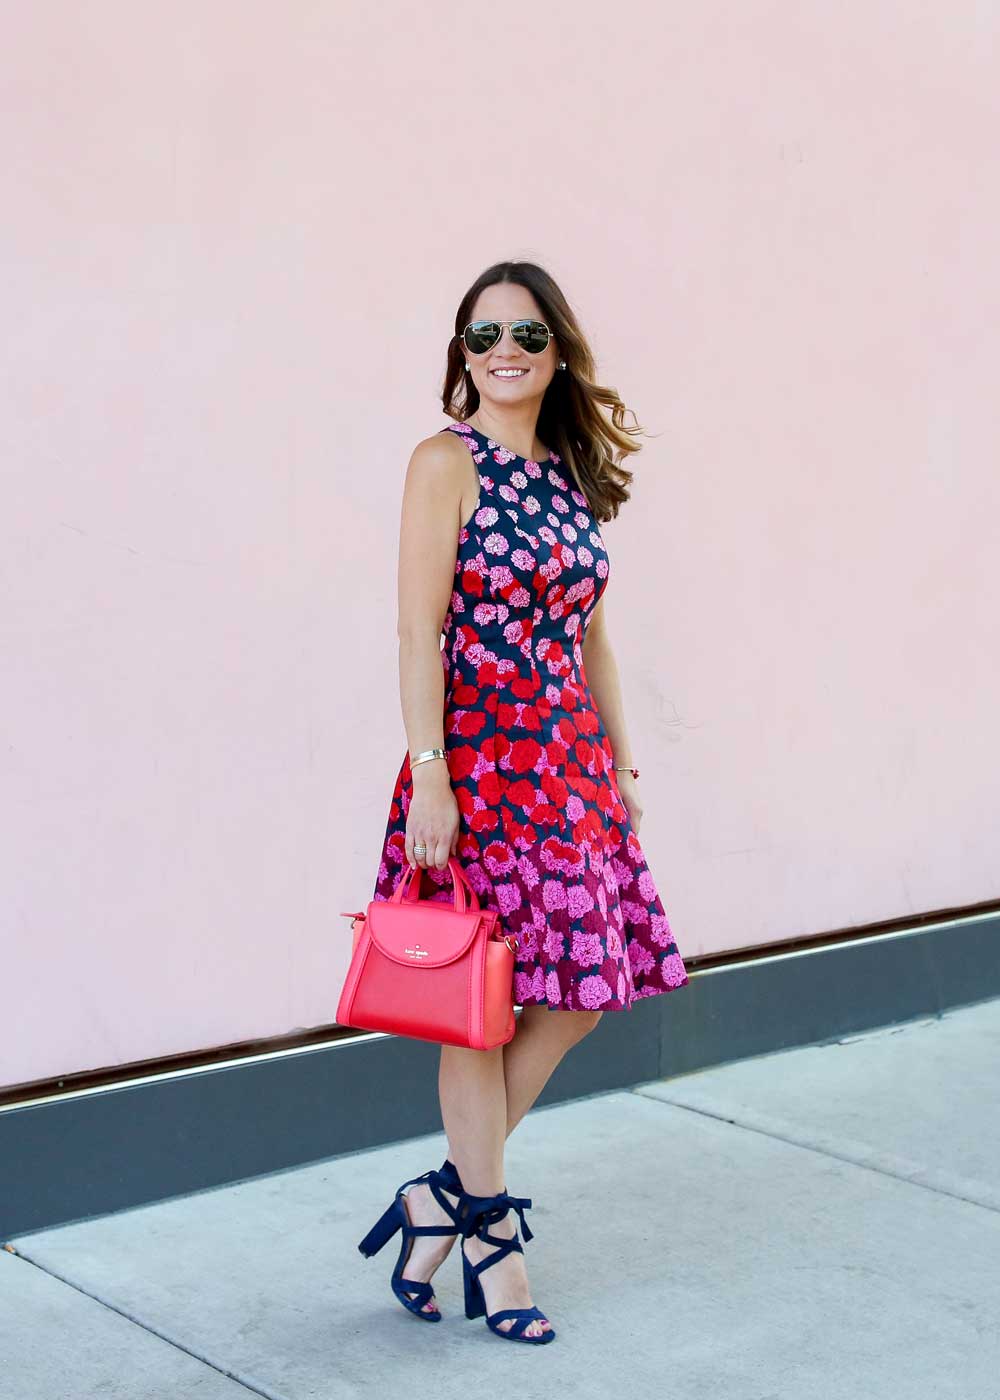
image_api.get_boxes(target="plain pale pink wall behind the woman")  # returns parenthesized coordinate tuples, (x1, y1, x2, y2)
(0, 0, 1000, 1084)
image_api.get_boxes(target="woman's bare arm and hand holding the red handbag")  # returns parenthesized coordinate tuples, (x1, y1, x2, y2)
(396, 437, 465, 869)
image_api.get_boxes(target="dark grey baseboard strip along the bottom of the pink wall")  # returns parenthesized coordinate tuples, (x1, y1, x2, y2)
(0, 913, 1000, 1242)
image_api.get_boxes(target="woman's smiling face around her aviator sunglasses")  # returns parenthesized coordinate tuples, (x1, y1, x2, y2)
(462, 281, 559, 412)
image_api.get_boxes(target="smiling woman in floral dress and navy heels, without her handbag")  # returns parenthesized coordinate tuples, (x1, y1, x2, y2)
(359, 262, 688, 1344)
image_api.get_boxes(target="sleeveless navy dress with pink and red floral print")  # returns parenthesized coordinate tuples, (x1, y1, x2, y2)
(373, 423, 688, 1011)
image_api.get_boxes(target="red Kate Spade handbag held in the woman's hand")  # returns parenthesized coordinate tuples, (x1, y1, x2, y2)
(336, 855, 517, 1050)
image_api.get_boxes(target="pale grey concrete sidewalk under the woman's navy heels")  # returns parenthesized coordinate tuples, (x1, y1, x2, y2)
(0, 1001, 1000, 1400)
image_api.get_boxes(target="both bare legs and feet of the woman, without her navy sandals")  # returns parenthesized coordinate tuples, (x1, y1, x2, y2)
(406, 1005, 601, 1336)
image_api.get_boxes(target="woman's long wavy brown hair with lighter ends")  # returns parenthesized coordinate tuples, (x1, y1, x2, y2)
(441, 262, 643, 522)
